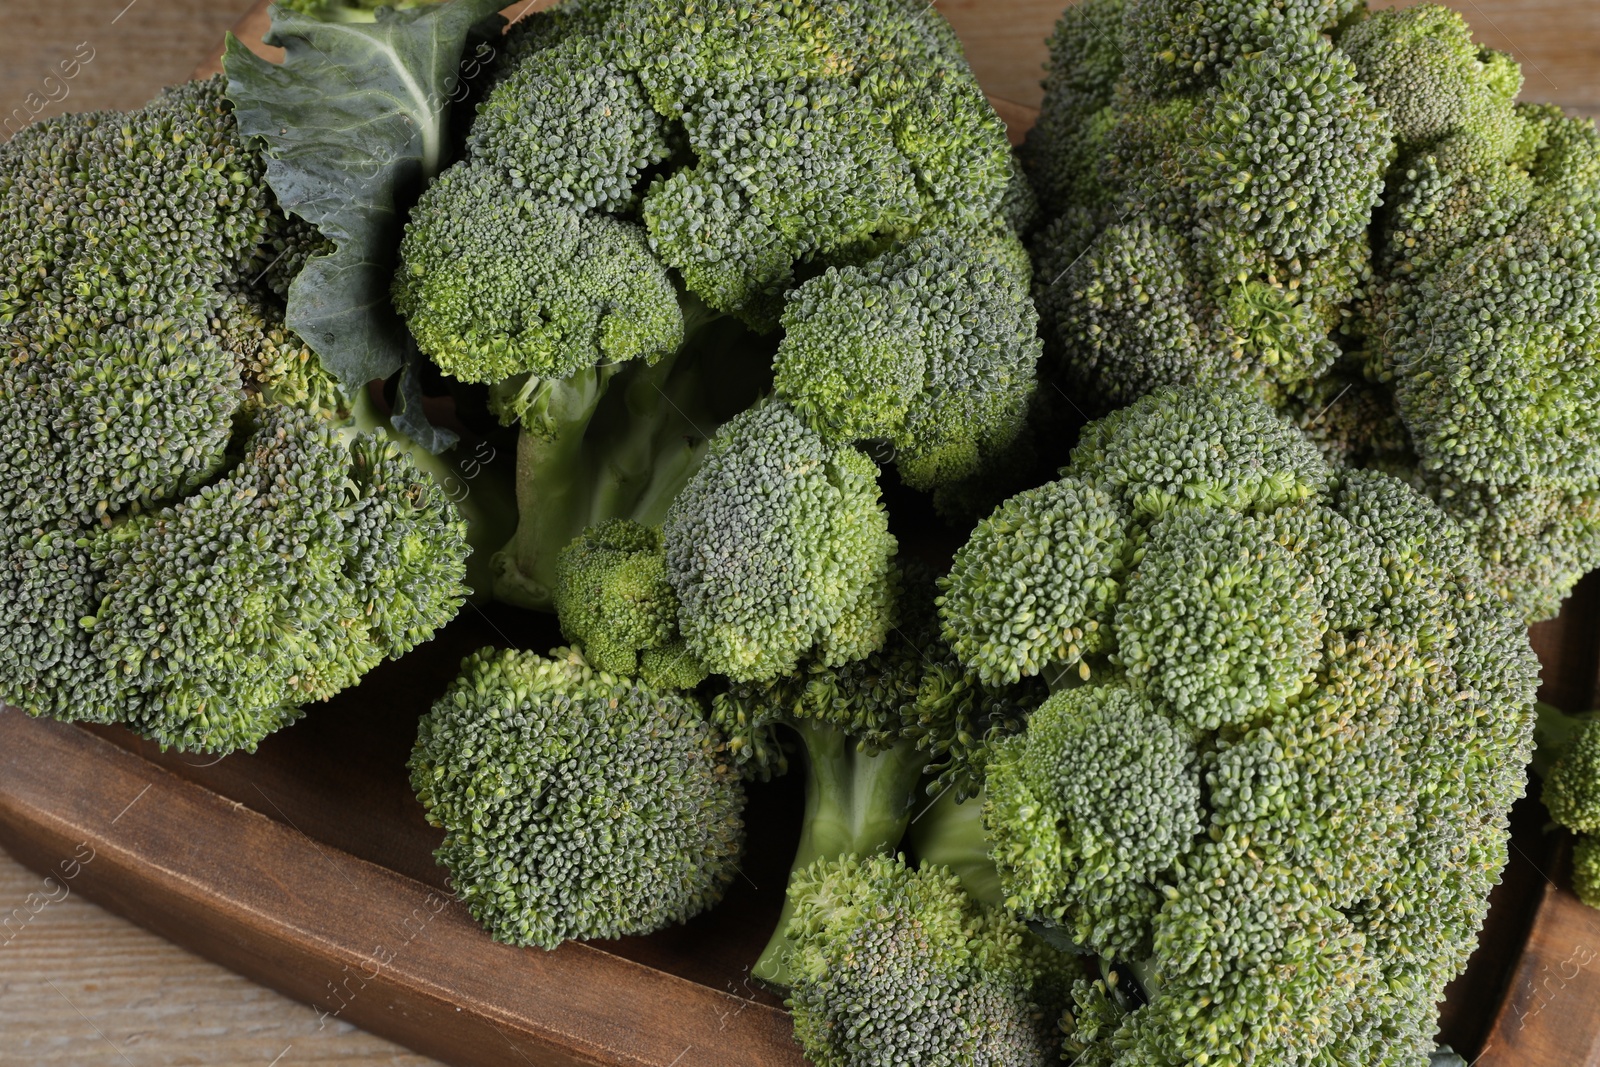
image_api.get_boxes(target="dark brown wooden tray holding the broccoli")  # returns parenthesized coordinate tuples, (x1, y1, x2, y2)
(0, 0, 1600, 1067)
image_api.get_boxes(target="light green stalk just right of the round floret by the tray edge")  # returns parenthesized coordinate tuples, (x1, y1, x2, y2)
(750, 721, 928, 989)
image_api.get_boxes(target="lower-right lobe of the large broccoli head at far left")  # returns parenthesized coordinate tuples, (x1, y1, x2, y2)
(80, 398, 466, 752)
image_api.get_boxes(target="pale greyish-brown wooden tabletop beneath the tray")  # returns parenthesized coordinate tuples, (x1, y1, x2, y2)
(0, 0, 1600, 1067)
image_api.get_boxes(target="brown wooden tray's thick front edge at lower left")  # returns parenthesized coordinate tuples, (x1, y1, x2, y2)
(0, 710, 802, 1067)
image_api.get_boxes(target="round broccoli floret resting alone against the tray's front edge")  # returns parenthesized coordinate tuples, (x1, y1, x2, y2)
(410, 648, 744, 949)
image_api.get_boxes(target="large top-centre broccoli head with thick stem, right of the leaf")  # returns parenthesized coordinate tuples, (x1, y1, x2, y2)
(394, 0, 1038, 608)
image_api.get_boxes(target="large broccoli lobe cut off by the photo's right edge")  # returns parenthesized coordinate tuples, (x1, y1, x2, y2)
(1363, 97, 1600, 619)
